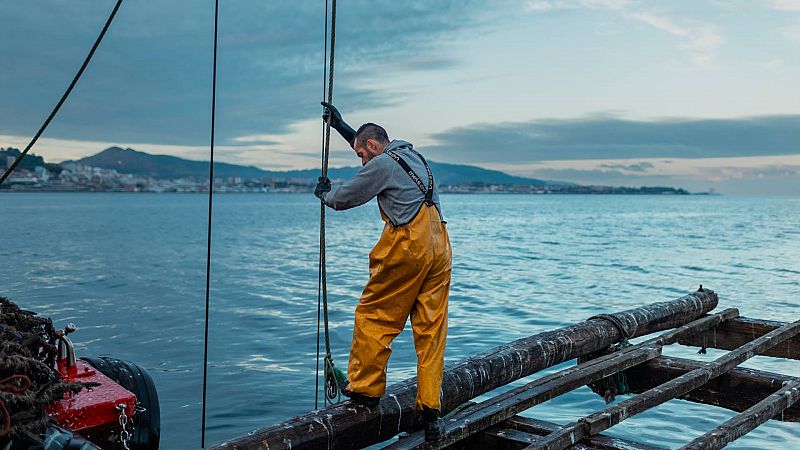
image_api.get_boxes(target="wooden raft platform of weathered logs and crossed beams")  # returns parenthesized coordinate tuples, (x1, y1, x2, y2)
(214, 286, 800, 450)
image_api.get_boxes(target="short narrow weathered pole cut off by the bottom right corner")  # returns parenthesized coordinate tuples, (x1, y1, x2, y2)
(681, 380, 800, 450)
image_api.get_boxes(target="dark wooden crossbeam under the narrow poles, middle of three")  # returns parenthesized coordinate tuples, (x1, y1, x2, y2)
(627, 356, 800, 422)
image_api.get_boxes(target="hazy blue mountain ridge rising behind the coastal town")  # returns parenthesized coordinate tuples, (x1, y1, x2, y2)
(72, 147, 548, 186)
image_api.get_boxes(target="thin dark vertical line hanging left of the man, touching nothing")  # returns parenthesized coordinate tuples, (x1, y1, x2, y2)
(200, 0, 219, 448)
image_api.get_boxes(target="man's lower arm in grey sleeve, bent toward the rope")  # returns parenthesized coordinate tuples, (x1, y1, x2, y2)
(322, 155, 397, 210)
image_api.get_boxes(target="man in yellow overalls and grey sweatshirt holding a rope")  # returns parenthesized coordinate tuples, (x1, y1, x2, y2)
(314, 102, 452, 440)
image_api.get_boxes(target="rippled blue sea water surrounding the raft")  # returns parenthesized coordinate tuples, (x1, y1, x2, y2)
(0, 193, 800, 449)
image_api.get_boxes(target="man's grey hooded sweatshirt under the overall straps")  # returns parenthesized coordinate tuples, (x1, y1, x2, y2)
(322, 140, 444, 226)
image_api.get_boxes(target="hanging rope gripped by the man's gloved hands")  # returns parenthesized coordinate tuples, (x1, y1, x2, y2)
(314, 0, 347, 408)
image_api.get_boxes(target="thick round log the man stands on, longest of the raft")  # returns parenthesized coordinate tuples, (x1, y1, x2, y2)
(214, 289, 718, 450)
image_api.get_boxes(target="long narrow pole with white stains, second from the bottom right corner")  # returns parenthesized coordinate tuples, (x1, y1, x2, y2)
(530, 321, 800, 450)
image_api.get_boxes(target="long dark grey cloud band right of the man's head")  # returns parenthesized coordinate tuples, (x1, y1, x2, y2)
(427, 116, 800, 164)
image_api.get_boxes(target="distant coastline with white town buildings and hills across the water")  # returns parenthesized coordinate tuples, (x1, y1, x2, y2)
(0, 147, 691, 195)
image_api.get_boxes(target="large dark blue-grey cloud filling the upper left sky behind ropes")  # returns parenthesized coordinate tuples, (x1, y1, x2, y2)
(0, 0, 484, 145)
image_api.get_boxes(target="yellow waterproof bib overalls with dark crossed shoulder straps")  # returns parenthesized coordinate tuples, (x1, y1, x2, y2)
(346, 152, 452, 410)
